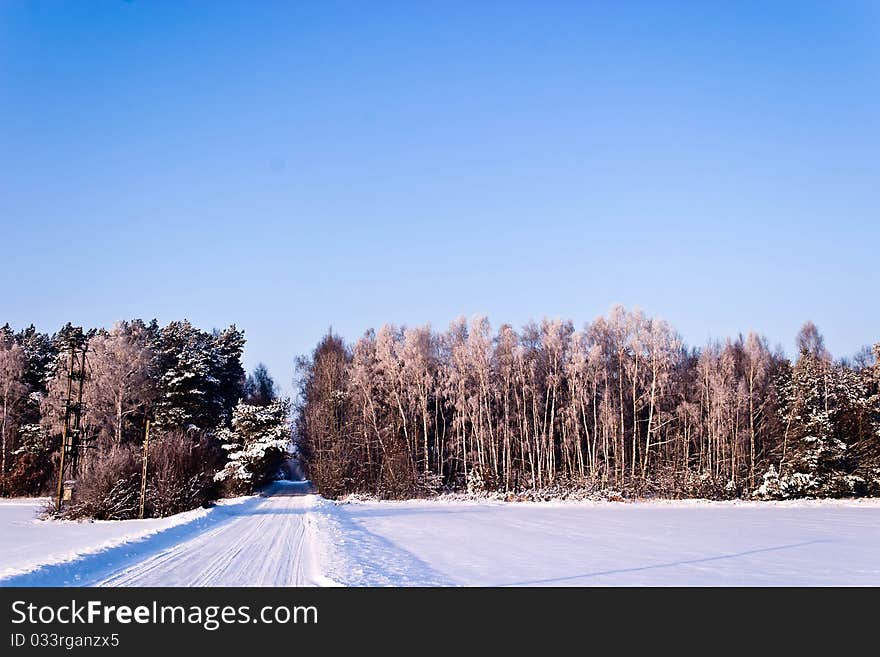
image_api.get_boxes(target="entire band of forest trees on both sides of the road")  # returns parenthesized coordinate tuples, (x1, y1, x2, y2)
(0, 308, 880, 518)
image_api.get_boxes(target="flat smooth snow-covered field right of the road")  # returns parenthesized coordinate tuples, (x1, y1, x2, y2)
(322, 501, 880, 586)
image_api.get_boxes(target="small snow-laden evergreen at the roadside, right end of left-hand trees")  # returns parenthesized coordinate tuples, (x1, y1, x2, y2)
(214, 399, 293, 492)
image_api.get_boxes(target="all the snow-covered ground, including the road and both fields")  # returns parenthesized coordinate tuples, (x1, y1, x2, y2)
(0, 484, 880, 586)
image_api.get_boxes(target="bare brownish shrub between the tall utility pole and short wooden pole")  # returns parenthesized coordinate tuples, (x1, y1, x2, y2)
(62, 446, 141, 520)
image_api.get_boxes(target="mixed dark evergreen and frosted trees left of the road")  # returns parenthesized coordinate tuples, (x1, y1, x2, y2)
(0, 320, 290, 519)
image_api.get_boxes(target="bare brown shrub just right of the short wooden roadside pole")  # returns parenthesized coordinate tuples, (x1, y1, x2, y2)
(145, 431, 222, 517)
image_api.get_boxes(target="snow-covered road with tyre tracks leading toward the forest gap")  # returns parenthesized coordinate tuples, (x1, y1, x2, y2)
(0, 482, 333, 586)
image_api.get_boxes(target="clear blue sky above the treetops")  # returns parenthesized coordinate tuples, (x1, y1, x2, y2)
(0, 0, 880, 390)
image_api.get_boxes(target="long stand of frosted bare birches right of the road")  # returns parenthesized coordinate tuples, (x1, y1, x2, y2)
(295, 307, 880, 498)
